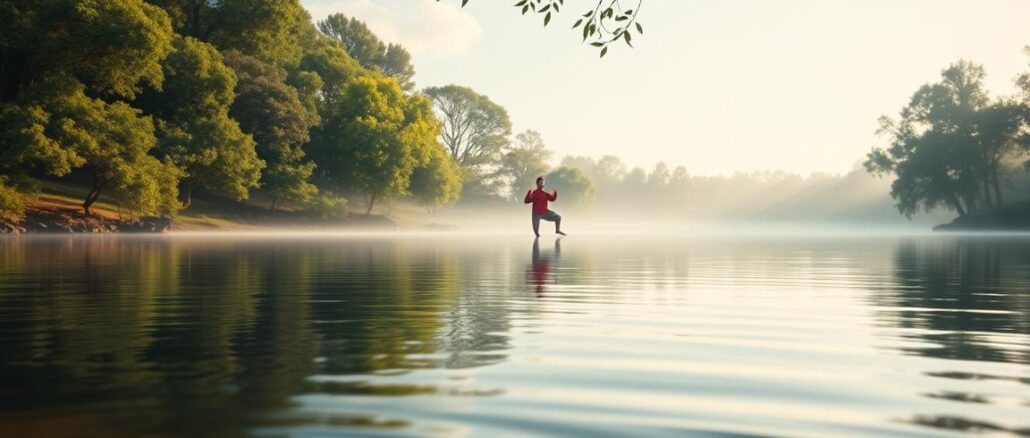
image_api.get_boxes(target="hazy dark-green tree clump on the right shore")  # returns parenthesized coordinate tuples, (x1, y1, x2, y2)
(865, 61, 1026, 217)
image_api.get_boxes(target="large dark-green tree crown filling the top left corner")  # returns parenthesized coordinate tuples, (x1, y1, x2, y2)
(0, 0, 172, 102)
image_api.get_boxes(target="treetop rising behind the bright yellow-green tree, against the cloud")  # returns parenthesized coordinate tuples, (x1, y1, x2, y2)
(318, 13, 415, 91)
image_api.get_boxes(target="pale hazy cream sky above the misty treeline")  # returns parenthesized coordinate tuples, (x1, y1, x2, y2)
(302, 0, 1030, 174)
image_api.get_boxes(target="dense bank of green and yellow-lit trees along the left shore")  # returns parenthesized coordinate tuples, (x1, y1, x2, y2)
(0, 0, 477, 216)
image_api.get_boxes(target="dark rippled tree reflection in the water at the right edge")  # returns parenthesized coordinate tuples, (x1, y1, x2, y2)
(876, 236, 1030, 435)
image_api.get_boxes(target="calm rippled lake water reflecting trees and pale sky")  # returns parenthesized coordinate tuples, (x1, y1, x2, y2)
(0, 235, 1030, 437)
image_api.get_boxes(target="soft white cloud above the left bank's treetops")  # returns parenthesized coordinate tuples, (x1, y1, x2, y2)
(302, 0, 482, 58)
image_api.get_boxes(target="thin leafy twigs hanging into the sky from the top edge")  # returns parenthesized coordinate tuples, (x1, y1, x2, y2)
(437, 0, 644, 58)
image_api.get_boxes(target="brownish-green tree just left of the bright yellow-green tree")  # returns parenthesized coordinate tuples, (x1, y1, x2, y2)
(225, 50, 318, 210)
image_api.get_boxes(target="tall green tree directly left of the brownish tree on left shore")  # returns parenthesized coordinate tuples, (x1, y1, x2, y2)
(138, 37, 265, 207)
